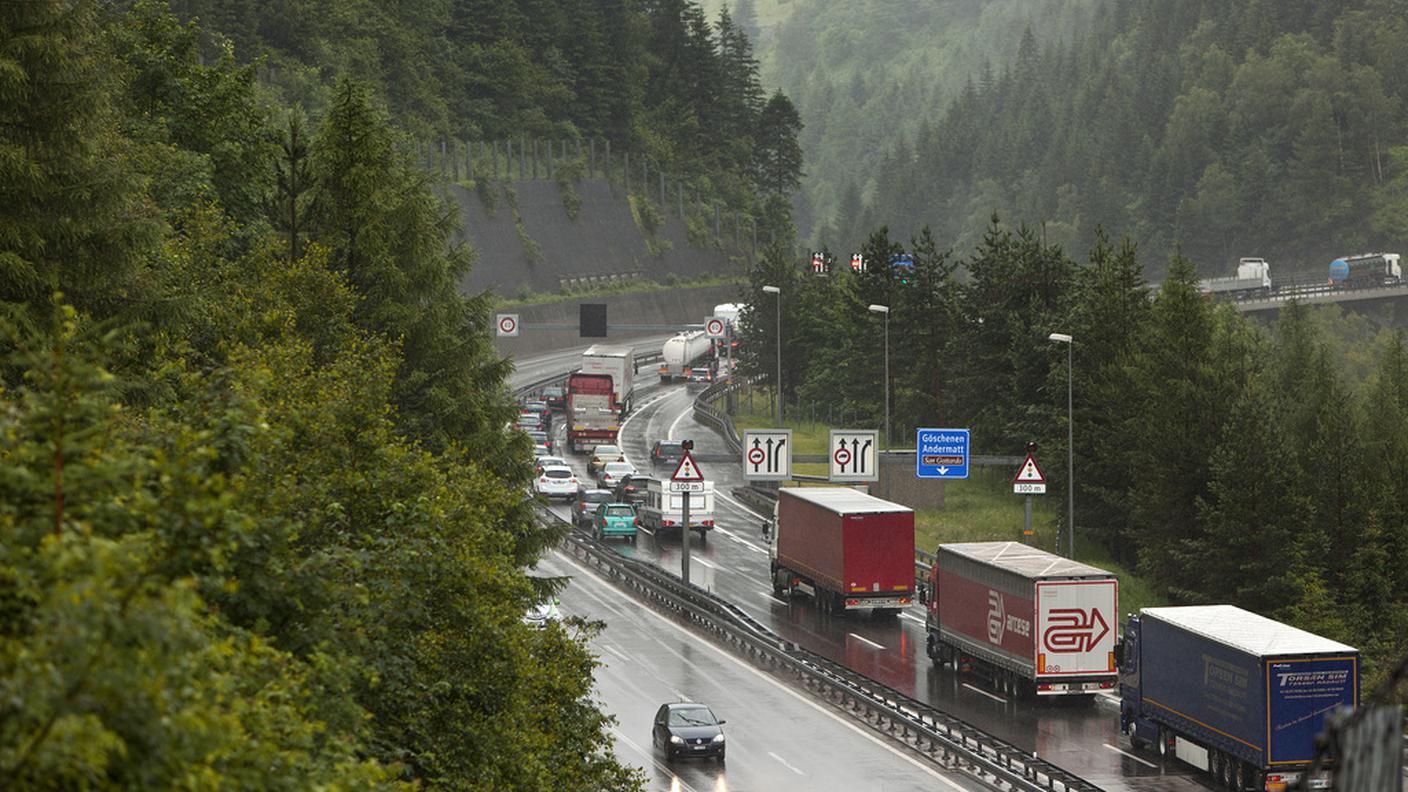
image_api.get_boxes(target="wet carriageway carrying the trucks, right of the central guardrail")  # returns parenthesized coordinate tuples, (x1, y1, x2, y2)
(512, 347, 1212, 791)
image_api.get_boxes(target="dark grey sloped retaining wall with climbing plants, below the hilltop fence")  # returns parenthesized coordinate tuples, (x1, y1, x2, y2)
(449, 179, 752, 297)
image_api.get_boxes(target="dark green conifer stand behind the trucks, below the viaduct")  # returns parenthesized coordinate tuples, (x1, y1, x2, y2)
(741, 225, 1408, 693)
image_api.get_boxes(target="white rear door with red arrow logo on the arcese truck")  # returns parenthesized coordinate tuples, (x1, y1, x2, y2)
(1036, 578, 1119, 676)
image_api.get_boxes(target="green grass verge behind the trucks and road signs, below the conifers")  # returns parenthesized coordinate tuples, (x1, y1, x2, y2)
(734, 389, 1169, 617)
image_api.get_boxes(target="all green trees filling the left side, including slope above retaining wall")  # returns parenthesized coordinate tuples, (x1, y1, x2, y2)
(0, 0, 796, 777)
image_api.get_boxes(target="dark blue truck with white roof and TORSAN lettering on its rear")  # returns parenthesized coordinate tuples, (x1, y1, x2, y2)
(1118, 605, 1359, 791)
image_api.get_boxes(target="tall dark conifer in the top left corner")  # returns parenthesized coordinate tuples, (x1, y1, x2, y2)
(0, 0, 158, 314)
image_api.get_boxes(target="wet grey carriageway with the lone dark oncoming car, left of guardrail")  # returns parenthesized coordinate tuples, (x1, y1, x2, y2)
(538, 552, 986, 792)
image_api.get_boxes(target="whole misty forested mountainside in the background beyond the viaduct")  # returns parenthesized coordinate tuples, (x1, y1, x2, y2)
(736, 0, 1408, 279)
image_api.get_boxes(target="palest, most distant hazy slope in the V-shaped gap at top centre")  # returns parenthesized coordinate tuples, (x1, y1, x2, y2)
(705, 0, 1098, 240)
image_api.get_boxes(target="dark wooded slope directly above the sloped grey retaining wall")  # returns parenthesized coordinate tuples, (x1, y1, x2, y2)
(170, 0, 801, 228)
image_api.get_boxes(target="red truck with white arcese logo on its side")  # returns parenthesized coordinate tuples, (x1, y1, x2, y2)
(924, 541, 1119, 696)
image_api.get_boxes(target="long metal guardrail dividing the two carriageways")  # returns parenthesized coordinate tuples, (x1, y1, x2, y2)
(539, 498, 1100, 792)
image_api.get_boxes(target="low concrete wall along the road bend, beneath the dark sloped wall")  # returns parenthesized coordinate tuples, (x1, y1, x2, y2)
(496, 283, 742, 358)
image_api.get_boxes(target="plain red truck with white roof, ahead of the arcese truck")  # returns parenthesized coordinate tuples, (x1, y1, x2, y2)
(769, 488, 914, 614)
